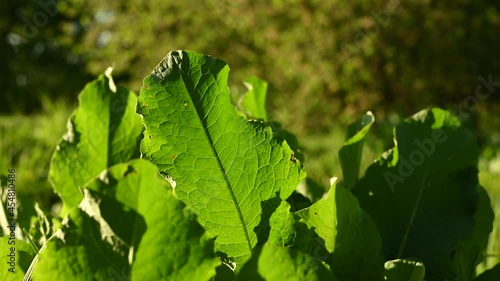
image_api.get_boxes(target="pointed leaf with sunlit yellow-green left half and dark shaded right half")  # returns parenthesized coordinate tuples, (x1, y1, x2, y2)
(296, 179, 383, 281)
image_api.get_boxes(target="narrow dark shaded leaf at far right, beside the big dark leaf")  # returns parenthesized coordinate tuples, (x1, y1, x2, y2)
(452, 186, 495, 281)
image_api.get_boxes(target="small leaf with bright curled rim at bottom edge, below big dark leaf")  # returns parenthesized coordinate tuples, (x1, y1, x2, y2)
(385, 259, 425, 281)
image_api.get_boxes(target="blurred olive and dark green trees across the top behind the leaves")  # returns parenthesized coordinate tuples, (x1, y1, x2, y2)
(1, 0, 500, 133)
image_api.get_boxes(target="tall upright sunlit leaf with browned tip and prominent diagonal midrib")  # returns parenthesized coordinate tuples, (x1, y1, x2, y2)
(137, 51, 305, 264)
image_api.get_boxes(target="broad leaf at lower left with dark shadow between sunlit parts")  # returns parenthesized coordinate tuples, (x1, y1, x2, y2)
(34, 160, 220, 281)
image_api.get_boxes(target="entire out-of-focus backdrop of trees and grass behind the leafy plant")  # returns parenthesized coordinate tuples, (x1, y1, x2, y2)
(0, 0, 500, 266)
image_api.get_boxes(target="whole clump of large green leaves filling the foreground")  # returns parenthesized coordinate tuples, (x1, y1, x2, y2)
(0, 51, 500, 281)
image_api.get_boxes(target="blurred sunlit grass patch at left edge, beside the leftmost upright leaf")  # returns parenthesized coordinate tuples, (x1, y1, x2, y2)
(0, 96, 73, 229)
